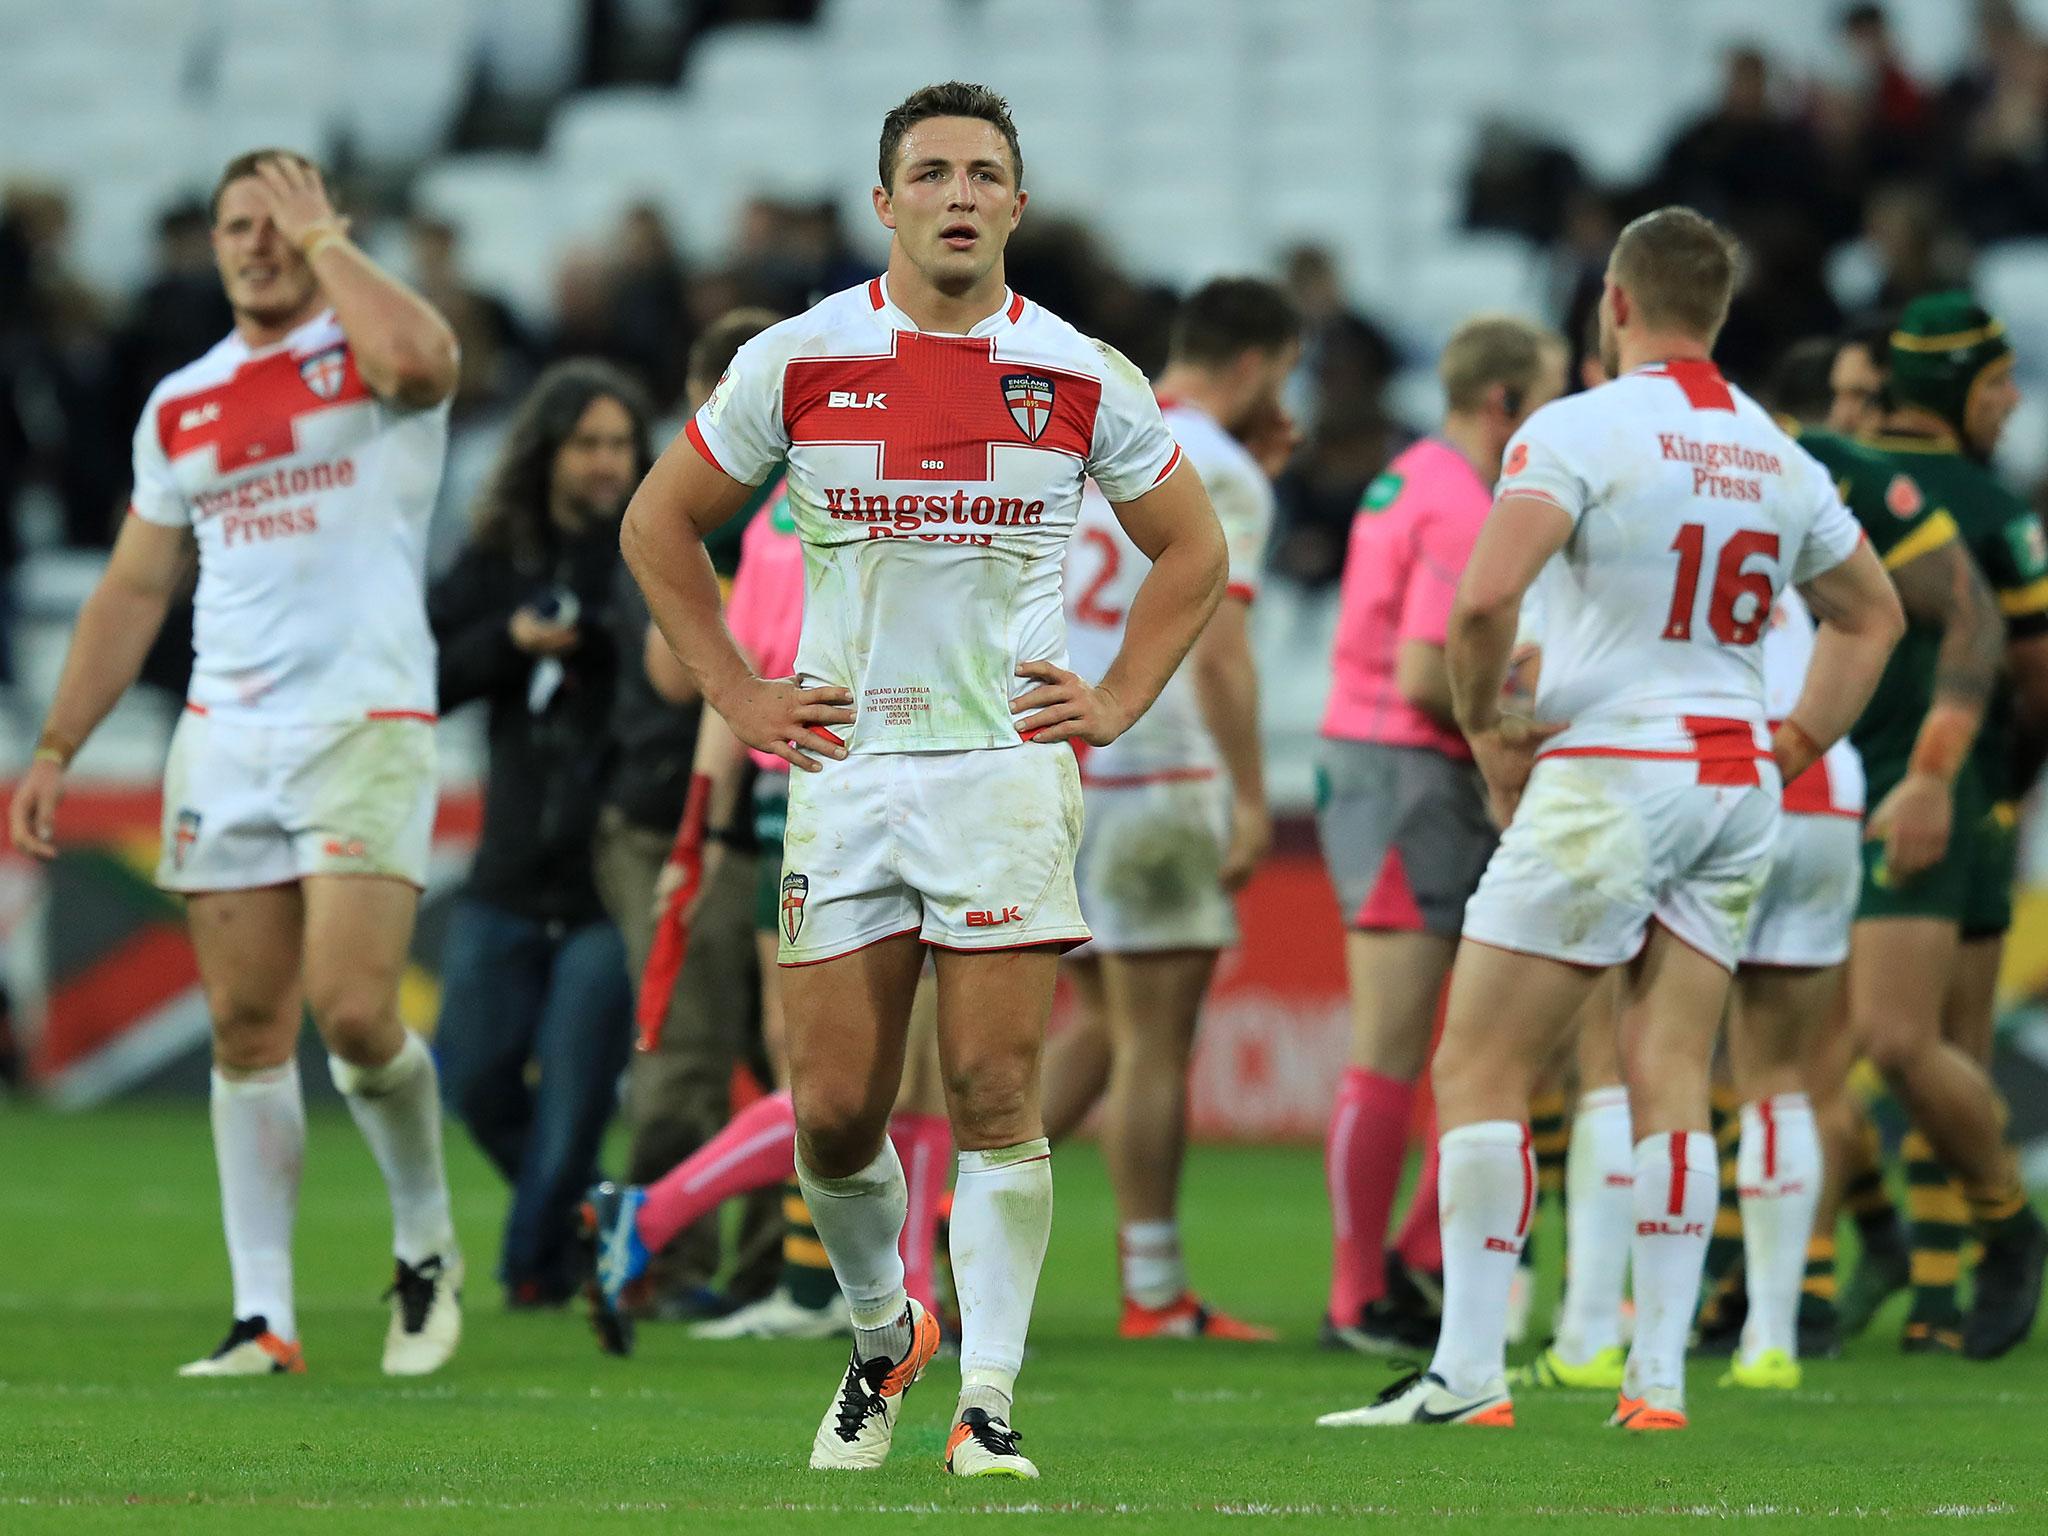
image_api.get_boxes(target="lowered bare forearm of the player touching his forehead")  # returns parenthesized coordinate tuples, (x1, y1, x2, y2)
(45, 516, 197, 752)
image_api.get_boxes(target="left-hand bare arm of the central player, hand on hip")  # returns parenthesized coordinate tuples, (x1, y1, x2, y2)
(618, 436, 854, 772)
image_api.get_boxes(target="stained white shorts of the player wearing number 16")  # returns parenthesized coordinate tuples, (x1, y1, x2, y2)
(1464, 756, 1780, 971)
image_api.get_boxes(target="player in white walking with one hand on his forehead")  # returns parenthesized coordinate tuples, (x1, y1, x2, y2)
(10, 150, 463, 1376)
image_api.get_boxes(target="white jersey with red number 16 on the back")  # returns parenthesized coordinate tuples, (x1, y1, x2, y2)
(1495, 360, 1862, 782)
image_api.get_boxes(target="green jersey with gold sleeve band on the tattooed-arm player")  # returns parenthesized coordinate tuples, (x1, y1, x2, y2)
(1798, 432, 1962, 782)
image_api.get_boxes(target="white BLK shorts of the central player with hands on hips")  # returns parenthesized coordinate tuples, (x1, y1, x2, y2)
(776, 741, 1087, 965)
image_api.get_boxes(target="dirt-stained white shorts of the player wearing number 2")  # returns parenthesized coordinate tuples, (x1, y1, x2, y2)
(1079, 774, 1237, 954)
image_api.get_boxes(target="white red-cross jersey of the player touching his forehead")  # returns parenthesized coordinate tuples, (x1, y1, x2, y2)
(129, 311, 449, 723)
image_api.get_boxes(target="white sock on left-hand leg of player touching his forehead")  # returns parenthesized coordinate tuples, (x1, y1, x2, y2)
(213, 1061, 305, 1339)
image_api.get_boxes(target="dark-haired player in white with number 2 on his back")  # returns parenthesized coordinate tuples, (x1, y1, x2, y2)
(1047, 279, 1300, 1339)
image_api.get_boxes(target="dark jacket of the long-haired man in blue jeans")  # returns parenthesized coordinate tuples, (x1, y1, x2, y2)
(426, 522, 637, 924)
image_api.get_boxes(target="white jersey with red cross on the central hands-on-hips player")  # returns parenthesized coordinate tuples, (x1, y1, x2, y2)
(684, 279, 1180, 752)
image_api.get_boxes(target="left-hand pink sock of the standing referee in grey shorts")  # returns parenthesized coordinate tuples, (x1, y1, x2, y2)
(1323, 1067, 1415, 1323)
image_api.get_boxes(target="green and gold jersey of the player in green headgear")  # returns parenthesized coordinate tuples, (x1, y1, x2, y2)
(1864, 436, 2048, 805)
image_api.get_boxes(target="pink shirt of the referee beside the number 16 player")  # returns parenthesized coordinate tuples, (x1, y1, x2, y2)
(1323, 438, 1493, 760)
